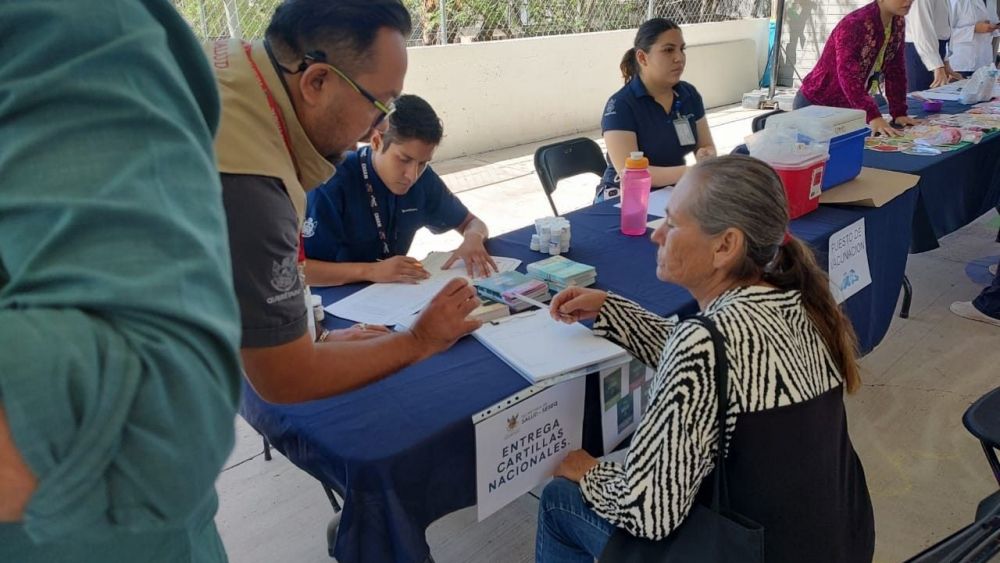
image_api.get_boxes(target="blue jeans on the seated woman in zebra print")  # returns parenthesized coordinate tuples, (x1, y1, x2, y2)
(535, 477, 615, 563)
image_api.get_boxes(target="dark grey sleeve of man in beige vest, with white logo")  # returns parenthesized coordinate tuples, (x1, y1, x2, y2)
(222, 174, 308, 348)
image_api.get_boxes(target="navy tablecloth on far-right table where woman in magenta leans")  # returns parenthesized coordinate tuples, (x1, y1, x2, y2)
(864, 100, 1000, 253)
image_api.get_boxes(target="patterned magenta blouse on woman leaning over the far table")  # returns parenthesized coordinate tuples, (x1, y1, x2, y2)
(800, 2, 906, 121)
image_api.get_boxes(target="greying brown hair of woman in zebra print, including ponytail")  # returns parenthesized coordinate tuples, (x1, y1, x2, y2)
(691, 155, 861, 393)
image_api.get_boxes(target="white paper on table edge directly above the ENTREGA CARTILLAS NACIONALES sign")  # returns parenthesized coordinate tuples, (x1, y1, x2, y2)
(472, 309, 628, 383)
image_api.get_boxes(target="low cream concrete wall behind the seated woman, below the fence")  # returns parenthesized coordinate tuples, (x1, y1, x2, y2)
(405, 19, 768, 159)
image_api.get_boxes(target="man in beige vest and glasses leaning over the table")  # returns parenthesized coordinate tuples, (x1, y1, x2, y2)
(207, 0, 479, 403)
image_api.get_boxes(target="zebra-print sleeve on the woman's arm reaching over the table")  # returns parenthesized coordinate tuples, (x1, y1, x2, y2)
(594, 293, 677, 368)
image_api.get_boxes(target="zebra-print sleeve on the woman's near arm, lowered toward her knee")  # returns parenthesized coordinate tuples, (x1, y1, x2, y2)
(580, 323, 718, 540)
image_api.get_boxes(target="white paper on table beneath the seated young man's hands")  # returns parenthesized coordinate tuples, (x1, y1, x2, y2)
(326, 252, 521, 326)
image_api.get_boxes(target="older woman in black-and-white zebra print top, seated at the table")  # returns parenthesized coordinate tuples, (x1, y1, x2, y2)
(536, 156, 874, 563)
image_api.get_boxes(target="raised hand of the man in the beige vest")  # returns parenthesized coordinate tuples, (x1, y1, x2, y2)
(410, 278, 482, 357)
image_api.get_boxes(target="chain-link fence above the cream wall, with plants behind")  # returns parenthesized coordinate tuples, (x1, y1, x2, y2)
(174, 0, 771, 45)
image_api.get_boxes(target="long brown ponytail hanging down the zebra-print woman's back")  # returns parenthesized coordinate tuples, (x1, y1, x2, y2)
(764, 237, 861, 393)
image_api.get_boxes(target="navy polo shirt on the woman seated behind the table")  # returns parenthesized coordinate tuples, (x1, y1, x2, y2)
(601, 77, 705, 186)
